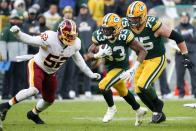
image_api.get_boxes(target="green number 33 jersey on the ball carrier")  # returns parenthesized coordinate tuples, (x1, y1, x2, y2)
(92, 29, 134, 71)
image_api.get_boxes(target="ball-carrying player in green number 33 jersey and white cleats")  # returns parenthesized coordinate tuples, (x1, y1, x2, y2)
(85, 13, 147, 126)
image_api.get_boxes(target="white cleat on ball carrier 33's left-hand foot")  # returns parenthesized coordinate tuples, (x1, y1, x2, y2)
(102, 105, 117, 123)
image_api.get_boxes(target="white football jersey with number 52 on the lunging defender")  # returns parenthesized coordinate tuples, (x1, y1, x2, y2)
(33, 31, 81, 74)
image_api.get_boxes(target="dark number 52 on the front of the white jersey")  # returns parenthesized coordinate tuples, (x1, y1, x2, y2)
(44, 54, 67, 69)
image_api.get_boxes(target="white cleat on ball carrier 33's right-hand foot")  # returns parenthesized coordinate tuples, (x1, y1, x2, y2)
(135, 107, 148, 126)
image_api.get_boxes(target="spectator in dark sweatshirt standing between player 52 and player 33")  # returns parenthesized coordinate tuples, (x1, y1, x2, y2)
(75, 4, 97, 97)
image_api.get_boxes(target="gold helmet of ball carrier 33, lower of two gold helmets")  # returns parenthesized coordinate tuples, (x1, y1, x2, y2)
(101, 13, 122, 39)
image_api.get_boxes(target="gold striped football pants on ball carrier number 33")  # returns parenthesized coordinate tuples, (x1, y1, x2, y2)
(99, 68, 128, 97)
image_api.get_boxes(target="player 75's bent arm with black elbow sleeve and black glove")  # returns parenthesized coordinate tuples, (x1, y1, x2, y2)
(155, 24, 193, 69)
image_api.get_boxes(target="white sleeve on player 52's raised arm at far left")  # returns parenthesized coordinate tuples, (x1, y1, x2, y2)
(17, 31, 48, 47)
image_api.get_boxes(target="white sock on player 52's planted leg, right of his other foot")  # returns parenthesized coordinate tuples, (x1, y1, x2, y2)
(32, 99, 52, 115)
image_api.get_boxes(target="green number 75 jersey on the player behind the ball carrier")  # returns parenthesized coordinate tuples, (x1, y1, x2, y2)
(122, 16, 165, 59)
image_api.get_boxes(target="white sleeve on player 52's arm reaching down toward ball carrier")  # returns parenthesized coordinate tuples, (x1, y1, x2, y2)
(72, 51, 93, 78)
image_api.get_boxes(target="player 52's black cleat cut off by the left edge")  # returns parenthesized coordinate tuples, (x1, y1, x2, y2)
(0, 102, 11, 121)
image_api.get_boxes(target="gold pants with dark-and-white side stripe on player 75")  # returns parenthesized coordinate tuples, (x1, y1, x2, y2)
(134, 55, 166, 93)
